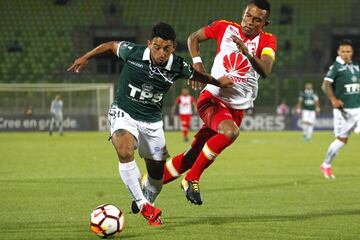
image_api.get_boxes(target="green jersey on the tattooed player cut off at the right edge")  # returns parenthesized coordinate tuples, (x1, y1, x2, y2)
(325, 56, 360, 108)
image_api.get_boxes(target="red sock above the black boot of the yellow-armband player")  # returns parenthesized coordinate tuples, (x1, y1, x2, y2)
(185, 133, 233, 181)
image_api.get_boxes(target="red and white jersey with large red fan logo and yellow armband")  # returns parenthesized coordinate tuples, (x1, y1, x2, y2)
(205, 20, 276, 109)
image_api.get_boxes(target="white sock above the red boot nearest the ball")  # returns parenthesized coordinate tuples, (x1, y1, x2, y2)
(119, 160, 148, 209)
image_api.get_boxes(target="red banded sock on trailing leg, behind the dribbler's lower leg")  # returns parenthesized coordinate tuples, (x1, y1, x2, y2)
(163, 152, 191, 184)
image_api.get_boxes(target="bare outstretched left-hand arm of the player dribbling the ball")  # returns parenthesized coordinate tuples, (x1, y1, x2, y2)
(67, 41, 119, 73)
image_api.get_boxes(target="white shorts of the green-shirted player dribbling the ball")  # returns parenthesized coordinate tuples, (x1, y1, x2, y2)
(108, 105, 169, 161)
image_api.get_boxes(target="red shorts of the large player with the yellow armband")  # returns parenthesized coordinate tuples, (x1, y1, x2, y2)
(197, 91, 244, 132)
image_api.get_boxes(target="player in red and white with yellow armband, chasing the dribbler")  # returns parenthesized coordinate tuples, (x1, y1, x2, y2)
(163, 0, 276, 205)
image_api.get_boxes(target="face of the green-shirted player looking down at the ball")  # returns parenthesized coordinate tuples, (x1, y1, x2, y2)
(148, 37, 175, 66)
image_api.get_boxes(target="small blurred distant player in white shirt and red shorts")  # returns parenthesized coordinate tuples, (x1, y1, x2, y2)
(174, 87, 196, 142)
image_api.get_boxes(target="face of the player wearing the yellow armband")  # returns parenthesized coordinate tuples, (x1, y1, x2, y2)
(241, 4, 268, 37)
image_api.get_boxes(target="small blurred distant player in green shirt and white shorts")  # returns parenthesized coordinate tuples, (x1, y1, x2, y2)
(296, 83, 320, 141)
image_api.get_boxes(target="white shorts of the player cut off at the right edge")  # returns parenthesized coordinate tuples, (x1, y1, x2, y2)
(333, 108, 360, 138)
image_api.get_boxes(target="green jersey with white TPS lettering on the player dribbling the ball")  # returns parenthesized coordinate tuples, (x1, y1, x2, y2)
(113, 42, 194, 122)
